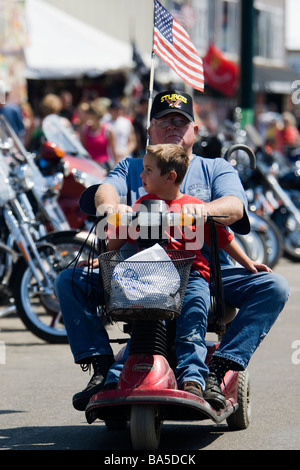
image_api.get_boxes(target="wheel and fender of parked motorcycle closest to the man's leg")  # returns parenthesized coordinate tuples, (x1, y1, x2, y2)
(13, 232, 96, 344)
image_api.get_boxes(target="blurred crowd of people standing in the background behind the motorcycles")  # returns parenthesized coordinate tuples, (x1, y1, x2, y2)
(0, 85, 300, 169)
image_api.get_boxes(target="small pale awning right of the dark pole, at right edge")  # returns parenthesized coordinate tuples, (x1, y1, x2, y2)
(254, 65, 300, 95)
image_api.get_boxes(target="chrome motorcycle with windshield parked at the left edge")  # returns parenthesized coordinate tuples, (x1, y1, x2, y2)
(0, 115, 97, 343)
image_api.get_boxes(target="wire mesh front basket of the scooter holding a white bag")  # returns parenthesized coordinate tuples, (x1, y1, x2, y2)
(99, 250, 195, 321)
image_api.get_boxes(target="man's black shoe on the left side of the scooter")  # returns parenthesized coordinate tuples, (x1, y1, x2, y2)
(73, 355, 114, 411)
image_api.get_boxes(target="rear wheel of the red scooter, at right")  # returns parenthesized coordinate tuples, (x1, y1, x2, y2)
(226, 369, 251, 431)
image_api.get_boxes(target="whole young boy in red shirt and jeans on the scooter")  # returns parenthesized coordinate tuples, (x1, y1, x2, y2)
(106, 144, 271, 408)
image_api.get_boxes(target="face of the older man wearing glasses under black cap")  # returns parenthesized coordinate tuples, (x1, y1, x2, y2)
(149, 113, 199, 152)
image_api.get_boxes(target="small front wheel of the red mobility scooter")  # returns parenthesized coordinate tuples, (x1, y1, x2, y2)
(130, 405, 161, 450)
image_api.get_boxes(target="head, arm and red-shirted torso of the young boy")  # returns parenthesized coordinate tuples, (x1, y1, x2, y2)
(107, 144, 271, 281)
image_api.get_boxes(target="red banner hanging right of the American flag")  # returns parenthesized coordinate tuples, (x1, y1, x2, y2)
(203, 44, 239, 97)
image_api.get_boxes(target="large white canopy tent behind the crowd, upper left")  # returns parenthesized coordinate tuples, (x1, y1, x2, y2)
(24, 0, 137, 79)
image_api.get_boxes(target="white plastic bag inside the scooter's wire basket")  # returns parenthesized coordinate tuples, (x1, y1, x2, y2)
(110, 243, 180, 308)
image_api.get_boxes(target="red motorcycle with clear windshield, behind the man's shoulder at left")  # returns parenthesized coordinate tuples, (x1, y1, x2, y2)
(36, 114, 107, 229)
